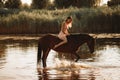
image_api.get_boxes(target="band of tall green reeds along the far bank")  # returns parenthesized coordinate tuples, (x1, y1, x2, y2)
(0, 7, 120, 34)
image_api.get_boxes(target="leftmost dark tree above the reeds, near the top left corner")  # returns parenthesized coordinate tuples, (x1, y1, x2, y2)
(5, 0, 22, 8)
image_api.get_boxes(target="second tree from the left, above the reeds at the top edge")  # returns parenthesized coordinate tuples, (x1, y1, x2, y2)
(32, 0, 49, 9)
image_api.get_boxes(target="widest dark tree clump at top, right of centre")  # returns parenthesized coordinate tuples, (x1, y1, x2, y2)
(54, 0, 102, 8)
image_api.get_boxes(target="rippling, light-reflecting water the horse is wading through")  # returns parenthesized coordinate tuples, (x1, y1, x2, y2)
(0, 37, 120, 80)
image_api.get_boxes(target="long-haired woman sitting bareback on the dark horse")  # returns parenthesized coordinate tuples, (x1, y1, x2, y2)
(54, 17, 72, 49)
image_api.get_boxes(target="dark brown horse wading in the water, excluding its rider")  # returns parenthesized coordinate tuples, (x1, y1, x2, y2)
(37, 34, 95, 67)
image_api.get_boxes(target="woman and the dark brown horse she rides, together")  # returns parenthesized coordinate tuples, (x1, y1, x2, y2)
(37, 17, 94, 68)
